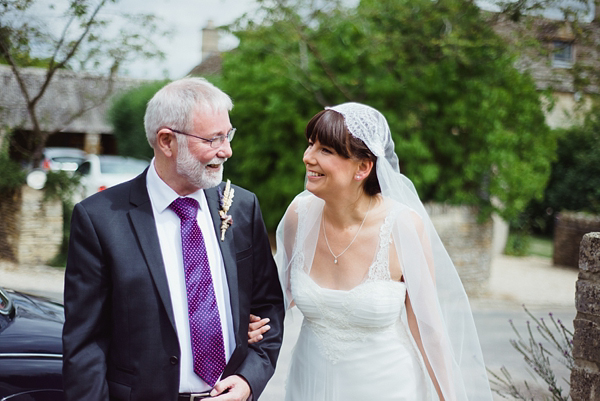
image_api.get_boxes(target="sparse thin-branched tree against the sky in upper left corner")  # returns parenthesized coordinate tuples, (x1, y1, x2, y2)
(0, 0, 163, 166)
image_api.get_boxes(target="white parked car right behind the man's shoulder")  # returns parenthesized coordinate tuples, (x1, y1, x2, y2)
(76, 154, 149, 198)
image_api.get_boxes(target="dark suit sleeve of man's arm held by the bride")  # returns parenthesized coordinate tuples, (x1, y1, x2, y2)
(236, 196, 285, 399)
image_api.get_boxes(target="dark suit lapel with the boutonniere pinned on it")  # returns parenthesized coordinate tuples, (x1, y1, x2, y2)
(204, 184, 240, 338)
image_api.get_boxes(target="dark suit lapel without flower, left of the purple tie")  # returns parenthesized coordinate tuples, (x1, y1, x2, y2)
(129, 170, 175, 329)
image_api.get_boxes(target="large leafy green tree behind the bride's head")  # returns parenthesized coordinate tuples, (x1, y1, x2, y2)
(220, 0, 556, 229)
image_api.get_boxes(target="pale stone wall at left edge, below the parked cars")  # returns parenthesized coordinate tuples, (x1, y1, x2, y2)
(0, 186, 63, 266)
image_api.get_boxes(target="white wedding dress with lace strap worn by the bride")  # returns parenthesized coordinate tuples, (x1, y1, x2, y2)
(285, 211, 437, 401)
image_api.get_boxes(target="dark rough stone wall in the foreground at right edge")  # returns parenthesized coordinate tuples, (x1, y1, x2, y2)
(571, 232, 600, 401)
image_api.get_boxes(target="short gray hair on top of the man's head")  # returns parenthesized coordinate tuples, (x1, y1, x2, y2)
(144, 77, 233, 148)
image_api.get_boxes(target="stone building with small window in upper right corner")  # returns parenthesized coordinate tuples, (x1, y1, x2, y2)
(486, 7, 600, 128)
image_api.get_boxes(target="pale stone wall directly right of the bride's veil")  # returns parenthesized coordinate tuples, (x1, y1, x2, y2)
(425, 203, 494, 296)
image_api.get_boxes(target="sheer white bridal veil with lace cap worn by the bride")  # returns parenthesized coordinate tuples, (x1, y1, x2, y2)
(276, 103, 492, 401)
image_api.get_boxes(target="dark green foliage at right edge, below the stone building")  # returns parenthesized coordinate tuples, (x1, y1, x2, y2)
(524, 103, 600, 234)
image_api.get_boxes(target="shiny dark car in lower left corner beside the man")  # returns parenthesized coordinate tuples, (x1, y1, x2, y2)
(0, 288, 65, 401)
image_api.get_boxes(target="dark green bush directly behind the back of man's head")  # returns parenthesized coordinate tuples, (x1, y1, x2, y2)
(108, 81, 168, 159)
